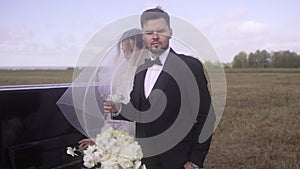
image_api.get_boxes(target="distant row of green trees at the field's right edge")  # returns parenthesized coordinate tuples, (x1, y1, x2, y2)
(232, 50, 300, 68)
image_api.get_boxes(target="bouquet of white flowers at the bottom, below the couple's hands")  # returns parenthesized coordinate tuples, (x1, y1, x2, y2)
(67, 127, 146, 169)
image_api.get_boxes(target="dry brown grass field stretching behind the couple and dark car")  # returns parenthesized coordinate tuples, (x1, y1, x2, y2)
(0, 69, 300, 169)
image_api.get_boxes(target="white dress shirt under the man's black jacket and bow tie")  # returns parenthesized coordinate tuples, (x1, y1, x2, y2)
(144, 47, 170, 98)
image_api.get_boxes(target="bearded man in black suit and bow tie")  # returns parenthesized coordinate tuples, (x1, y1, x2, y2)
(104, 7, 211, 169)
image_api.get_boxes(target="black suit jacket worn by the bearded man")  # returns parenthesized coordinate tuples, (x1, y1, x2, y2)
(116, 49, 211, 169)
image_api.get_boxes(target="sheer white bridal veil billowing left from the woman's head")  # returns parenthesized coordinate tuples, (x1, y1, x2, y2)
(57, 29, 145, 139)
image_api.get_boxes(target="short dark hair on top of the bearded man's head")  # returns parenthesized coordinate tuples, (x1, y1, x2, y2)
(140, 6, 171, 28)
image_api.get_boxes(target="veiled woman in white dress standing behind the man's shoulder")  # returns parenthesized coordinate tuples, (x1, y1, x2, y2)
(78, 28, 146, 149)
